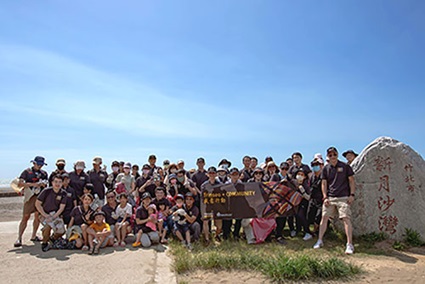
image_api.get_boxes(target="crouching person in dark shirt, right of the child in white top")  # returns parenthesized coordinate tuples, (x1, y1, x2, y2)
(133, 192, 159, 247)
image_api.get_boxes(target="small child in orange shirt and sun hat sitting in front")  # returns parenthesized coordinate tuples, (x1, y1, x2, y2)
(87, 211, 113, 254)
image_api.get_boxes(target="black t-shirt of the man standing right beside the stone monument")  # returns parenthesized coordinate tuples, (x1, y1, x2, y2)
(321, 160, 354, 197)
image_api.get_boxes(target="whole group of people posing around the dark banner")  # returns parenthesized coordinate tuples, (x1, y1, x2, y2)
(14, 147, 357, 254)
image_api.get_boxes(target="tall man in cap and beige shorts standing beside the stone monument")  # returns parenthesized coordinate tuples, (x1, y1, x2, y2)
(313, 147, 356, 254)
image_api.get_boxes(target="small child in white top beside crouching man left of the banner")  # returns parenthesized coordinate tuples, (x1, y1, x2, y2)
(171, 194, 192, 250)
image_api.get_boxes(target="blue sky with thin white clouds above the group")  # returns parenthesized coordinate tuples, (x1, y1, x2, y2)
(0, 0, 425, 178)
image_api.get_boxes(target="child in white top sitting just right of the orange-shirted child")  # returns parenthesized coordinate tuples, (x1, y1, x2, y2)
(114, 193, 133, 247)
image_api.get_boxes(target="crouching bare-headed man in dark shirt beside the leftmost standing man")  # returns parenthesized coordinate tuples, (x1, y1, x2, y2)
(35, 175, 67, 252)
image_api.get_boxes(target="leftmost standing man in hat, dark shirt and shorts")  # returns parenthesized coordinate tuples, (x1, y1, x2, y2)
(14, 156, 48, 247)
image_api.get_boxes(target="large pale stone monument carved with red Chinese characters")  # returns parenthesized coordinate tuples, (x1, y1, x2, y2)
(351, 137, 425, 240)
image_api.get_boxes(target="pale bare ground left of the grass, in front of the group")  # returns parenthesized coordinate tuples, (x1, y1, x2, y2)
(0, 197, 176, 283)
